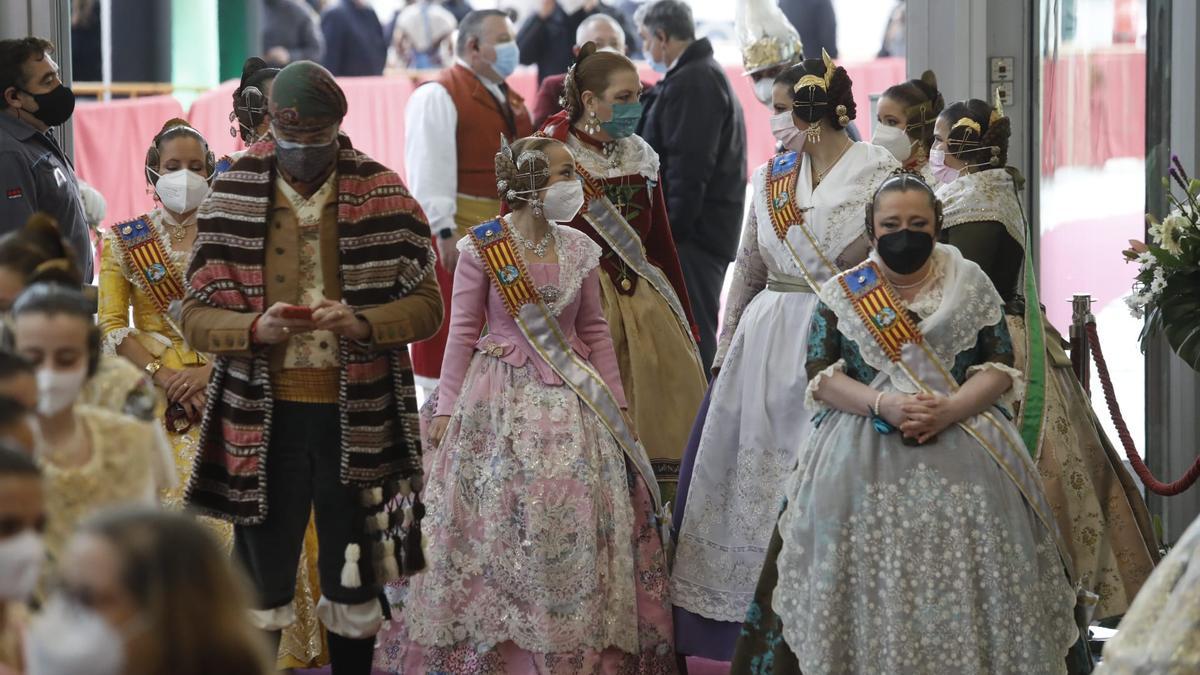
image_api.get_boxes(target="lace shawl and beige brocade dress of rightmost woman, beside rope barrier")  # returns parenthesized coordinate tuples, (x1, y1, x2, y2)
(938, 169, 1158, 620)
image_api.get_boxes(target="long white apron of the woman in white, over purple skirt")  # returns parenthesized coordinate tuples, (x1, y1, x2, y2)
(671, 284, 817, 659)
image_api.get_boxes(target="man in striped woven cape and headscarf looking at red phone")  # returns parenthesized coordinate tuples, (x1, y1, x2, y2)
(182, 61, 442, 674)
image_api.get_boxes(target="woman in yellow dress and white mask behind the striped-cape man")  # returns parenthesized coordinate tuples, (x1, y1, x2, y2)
(97, 119, 328, 669)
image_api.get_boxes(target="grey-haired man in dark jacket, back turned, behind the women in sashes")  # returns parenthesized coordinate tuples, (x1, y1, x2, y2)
(635, 0, 746, 369)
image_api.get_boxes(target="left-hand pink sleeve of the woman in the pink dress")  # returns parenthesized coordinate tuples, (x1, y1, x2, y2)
(434, 246, 489, 416)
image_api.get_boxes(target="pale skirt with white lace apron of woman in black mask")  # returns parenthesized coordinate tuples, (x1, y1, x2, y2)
(733, 401, 1079, 675)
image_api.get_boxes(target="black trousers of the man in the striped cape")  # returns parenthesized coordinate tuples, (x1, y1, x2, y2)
(234, 401, 380, 609)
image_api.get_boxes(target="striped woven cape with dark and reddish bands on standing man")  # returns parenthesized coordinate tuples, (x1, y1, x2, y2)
(187, 135, 434, 525)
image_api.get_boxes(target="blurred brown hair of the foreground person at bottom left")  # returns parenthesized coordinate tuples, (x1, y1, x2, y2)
(79, 507, 274, 675)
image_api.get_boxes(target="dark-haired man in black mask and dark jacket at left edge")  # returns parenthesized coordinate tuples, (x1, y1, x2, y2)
(0, 37, 92, 281)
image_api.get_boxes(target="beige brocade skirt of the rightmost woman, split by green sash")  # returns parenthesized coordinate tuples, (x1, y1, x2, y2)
(1007, 316, 1158, 619)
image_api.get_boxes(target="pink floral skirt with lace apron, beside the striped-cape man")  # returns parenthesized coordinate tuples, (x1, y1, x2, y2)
(377, 353, 674, 674)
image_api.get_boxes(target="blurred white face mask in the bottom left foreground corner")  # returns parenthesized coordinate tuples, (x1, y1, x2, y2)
(25, 596, 125, 675)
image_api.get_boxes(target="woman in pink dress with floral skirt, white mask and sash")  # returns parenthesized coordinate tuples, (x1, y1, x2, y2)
(377, 137, 676, 674)
